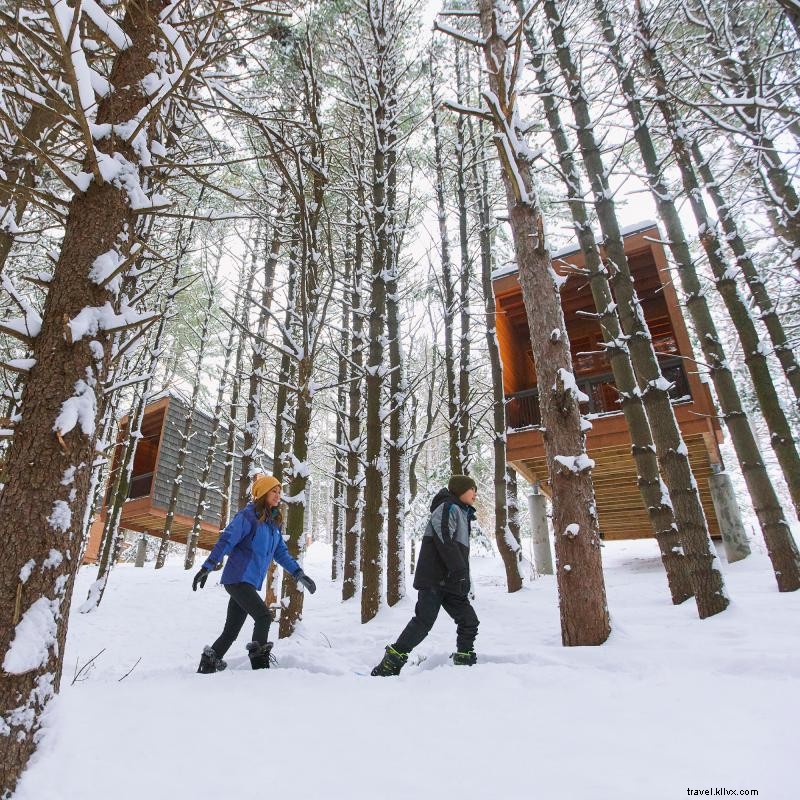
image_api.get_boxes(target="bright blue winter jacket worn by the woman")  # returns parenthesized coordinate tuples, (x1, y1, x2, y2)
(203, 503, 300, 590)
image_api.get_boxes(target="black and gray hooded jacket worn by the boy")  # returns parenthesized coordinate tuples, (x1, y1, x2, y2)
(414, 489, 475, 595)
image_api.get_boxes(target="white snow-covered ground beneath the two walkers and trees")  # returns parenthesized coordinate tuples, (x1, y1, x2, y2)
(15, 540, 800, 800)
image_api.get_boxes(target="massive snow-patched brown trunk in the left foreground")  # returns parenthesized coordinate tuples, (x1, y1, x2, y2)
(0, 0, 172, 795)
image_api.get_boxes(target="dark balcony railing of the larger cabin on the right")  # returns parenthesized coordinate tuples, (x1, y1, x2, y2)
(506, 356, 692, 430)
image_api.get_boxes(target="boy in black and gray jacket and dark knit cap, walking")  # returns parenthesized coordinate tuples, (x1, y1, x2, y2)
(372, 475, 478, 677)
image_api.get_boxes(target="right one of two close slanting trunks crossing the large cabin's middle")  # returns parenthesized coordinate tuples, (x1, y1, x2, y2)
(544, 0, 729, 619)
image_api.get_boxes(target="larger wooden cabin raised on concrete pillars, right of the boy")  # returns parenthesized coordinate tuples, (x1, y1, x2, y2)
(494, 222, 722, 539)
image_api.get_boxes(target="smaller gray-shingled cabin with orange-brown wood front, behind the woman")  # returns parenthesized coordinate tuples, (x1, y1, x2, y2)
(85, 393, 272, 561)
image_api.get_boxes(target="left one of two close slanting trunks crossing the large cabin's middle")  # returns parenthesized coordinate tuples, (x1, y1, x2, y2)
(517, 0, 693, 604)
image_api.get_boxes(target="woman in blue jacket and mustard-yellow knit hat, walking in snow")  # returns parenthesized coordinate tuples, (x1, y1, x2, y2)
(192, 475, 317, 673)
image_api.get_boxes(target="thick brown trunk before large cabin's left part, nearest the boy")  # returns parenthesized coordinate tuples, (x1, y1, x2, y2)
(480, 0, 611, 646)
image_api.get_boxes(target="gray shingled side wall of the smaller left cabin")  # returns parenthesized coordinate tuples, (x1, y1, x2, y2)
(152, 397, 272, 524)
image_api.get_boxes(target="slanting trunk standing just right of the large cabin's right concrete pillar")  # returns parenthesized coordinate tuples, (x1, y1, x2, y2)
(638, 3, 800, 591)
